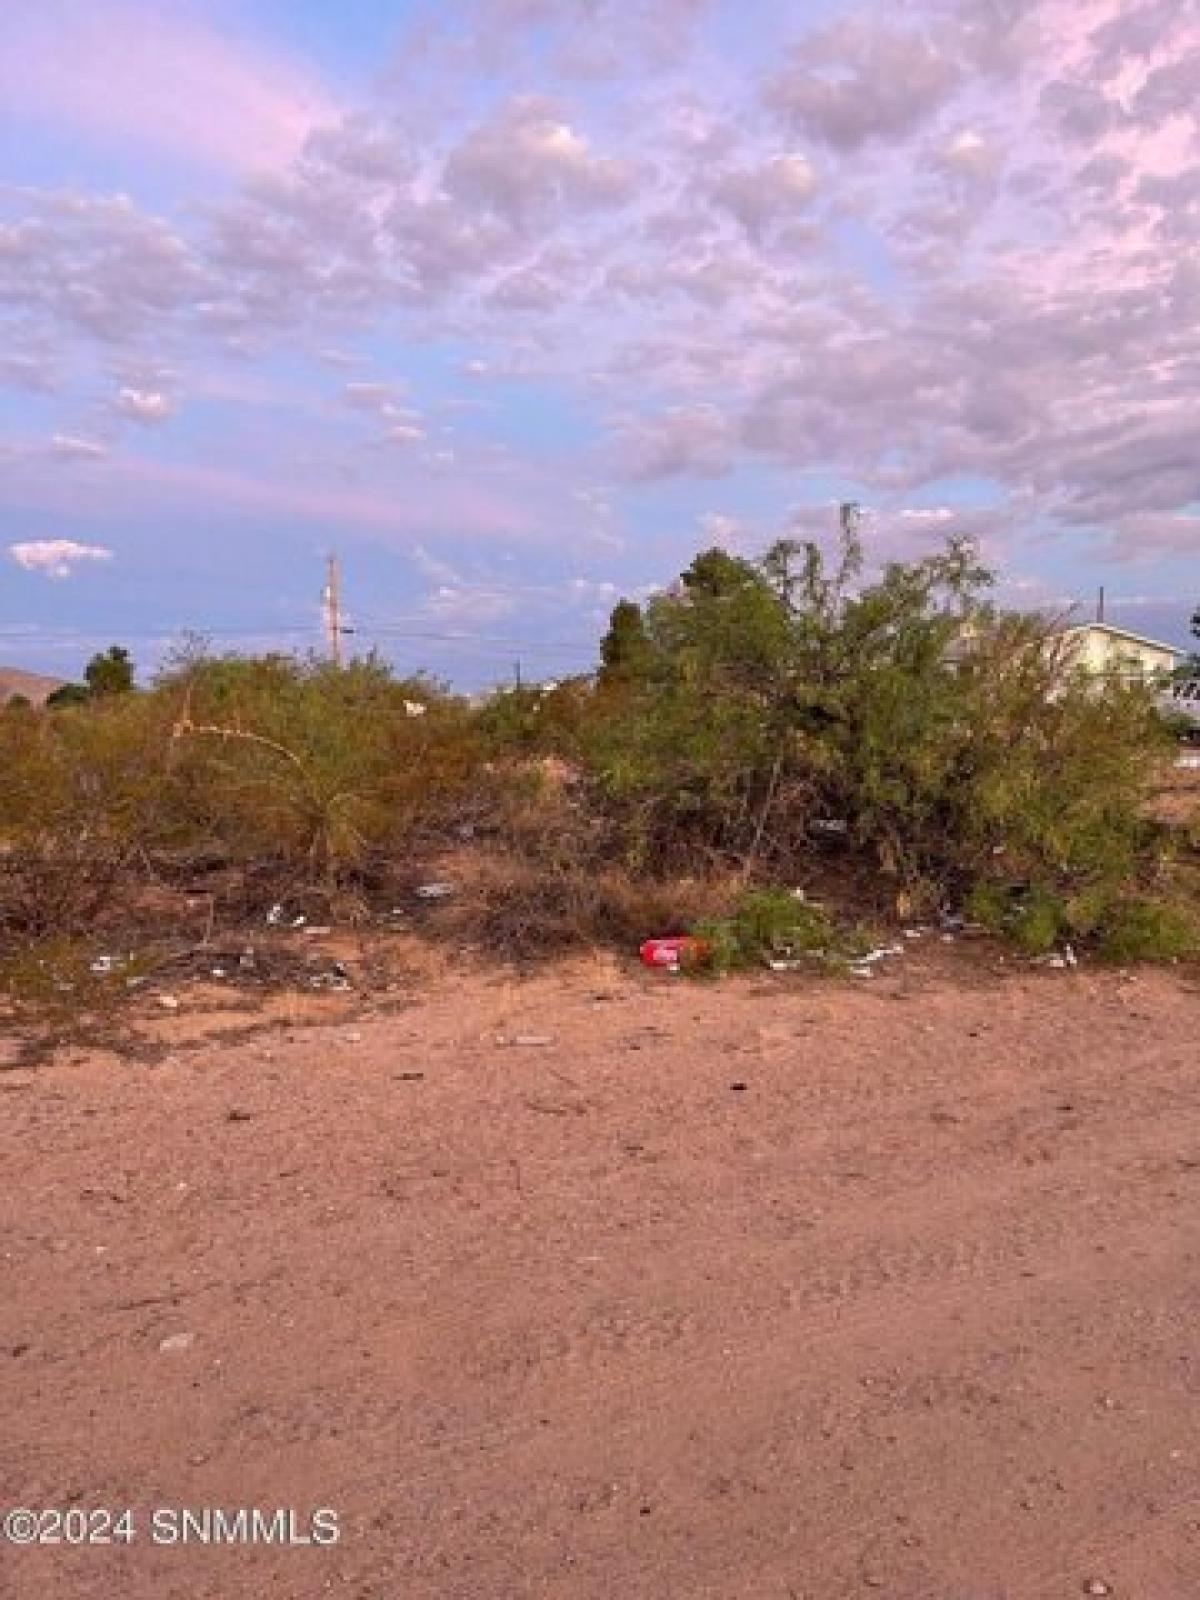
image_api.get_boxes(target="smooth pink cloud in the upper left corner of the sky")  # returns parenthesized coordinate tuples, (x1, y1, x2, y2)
(0, 0, 336, 173)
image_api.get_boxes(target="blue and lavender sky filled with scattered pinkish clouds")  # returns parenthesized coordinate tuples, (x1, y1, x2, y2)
(0, 0, 1200, 688)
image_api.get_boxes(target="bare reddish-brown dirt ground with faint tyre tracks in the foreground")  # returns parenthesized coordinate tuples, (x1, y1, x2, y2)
(0, 950, 1200, 1600)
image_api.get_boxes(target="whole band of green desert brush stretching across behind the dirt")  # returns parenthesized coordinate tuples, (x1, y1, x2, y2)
(0, 534, 1189, 966)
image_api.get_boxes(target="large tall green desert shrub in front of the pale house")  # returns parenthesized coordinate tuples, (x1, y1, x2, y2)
(589, 539, 1163, 928)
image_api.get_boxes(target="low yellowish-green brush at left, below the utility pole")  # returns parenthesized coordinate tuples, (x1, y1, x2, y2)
(0, 654, 482, 938)
